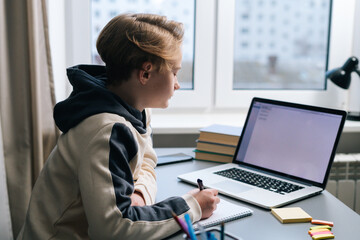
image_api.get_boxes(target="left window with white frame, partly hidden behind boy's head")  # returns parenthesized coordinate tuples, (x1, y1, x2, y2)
(61, 0, 216, 108)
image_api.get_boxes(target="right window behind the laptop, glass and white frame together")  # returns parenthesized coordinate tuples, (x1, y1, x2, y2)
(215, 0, 354, 108)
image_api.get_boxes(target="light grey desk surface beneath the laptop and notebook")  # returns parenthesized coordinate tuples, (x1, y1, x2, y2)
(156, 148, 360, 240)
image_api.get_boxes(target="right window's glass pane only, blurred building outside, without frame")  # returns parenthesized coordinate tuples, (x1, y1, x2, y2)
(233, 0, 331, 90)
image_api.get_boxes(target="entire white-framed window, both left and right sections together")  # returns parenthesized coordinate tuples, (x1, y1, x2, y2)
(49, 0, 360, 112)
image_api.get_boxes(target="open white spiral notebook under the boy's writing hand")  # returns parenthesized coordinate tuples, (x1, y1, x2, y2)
(194, 199, 253, 230)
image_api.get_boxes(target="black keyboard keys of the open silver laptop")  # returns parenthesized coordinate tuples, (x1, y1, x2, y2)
(214, 168, 304, 194)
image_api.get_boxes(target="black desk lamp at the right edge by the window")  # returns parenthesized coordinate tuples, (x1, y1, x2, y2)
(326, 57, 360, 121)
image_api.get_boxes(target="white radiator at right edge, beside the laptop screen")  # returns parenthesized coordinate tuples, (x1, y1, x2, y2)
(326, 153, 360, 214)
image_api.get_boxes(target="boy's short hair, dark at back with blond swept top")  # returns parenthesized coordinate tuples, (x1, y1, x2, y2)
(96, 14, 184, 85)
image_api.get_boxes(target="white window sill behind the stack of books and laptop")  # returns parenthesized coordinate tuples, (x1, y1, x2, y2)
(151, 111, 360, 134)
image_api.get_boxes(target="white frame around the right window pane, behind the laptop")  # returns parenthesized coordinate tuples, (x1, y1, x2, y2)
(215, 0, 354, 108)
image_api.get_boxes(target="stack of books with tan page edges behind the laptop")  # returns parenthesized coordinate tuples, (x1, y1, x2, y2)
(195, 124, 242, 163)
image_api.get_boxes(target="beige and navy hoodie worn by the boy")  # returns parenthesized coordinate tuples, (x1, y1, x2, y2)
(18, 65, 201, 239)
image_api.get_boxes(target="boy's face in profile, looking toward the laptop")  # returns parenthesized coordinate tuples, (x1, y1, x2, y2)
(147, 54, 182, 108)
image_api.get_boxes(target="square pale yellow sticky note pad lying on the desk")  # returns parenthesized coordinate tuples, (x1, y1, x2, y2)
(271, 207, 312, 223)
